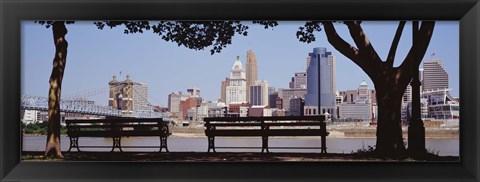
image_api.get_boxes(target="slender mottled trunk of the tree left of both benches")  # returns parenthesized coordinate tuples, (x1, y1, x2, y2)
(45, 21, 68, 158)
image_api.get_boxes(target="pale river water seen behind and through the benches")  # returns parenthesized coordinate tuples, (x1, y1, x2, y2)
(23, 136, 460, 156)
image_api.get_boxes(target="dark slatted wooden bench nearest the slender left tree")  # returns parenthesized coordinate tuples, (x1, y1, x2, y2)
(65, 118, 171, 152)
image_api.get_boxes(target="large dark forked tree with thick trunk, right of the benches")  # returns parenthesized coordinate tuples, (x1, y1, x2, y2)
(297, 21, 435, 156)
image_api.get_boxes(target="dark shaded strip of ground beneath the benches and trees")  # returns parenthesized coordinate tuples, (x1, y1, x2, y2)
(22, 152, 459, 162)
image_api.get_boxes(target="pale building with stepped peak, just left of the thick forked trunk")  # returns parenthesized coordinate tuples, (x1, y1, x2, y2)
(339, 81, 373, 121)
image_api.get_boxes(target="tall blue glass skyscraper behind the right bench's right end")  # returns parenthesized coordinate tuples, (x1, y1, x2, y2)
(305, 47, 336, 115)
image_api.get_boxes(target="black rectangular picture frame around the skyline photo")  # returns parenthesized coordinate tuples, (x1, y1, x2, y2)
(0, 0, 480, 181)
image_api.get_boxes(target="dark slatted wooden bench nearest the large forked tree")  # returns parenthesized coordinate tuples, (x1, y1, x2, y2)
(204, 115, 329, 153)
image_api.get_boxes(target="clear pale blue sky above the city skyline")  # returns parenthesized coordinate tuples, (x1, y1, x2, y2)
(21, 21, 460, 107)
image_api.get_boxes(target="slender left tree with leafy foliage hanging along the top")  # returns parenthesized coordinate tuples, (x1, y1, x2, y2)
(37, 21, 277, 158)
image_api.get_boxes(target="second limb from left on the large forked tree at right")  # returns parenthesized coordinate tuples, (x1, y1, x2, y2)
(345, 21, 382, 64)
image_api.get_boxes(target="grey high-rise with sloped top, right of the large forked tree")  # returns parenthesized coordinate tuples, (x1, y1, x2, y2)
(422, 59, 449, 91)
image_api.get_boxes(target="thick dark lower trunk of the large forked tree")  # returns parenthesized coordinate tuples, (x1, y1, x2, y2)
(374, 82, 405, 157)
